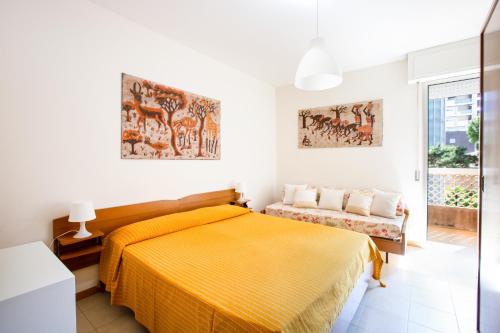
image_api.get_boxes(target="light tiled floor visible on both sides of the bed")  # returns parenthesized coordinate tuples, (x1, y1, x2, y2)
(77, 242, 477, 333)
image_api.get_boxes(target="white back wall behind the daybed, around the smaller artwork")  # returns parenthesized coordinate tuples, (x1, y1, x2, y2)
(275, 61, 425, 240)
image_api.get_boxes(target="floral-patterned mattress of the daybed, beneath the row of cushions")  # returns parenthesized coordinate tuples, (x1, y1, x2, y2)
(266, 202, 405, 240)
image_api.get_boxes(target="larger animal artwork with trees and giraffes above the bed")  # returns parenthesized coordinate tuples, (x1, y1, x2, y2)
(121, 74, 220, 160)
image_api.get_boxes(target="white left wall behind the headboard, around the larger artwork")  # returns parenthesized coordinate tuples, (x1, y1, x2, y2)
(0, 0, 276, 288)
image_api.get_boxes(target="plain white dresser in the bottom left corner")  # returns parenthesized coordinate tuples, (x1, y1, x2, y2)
(0, 242, 76, 333)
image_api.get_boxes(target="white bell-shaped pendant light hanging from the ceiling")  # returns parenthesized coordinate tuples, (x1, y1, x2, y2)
(295, 0, 342, 91)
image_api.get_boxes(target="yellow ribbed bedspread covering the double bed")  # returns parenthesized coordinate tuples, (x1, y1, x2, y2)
(100, 205, 382, 332)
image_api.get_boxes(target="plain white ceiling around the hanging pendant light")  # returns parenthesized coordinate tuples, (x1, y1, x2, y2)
(92, 0, 492, 86)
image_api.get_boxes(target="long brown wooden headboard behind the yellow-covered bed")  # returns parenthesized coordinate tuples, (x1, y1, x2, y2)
(52, 189, 239, 238)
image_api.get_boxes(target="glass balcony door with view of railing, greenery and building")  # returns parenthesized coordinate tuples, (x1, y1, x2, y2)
(427, 77, 481, 244)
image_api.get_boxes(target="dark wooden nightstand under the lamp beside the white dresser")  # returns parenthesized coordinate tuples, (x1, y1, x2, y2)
(54, 230, 104, 271)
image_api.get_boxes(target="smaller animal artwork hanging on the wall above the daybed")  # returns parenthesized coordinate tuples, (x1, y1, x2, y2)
(298, 99, 383, 148)
